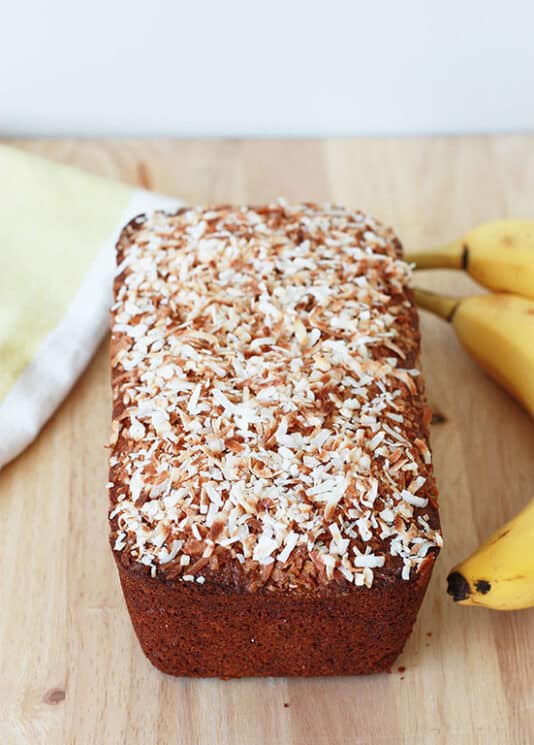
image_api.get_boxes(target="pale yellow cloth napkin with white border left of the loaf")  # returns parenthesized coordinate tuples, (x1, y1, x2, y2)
(0, 146, 178, 468)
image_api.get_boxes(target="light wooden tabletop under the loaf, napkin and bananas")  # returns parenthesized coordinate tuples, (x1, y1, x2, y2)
(0, 137, 534, 745)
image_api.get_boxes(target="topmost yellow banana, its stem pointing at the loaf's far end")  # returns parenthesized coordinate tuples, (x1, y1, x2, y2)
(406, 220, 534, 298)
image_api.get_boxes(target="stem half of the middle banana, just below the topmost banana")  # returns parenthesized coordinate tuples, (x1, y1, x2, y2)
(415, 289, 534, 417)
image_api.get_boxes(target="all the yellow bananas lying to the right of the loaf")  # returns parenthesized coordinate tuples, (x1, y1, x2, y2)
(406, 220, 534, 610)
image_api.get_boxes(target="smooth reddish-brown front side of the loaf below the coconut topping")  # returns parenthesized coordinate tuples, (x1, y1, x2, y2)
(115, 555, 435, 679)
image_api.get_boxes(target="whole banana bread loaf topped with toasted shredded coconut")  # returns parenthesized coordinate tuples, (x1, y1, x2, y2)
(108, 201, 442, 678)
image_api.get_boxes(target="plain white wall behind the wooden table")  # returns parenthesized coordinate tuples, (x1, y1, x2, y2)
(0, 0, 534, 136)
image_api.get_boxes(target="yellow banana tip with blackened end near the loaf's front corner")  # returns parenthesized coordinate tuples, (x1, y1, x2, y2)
(447, 499, 534, 610)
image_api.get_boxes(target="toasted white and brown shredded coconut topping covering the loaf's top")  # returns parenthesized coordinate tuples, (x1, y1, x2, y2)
(110, 203, 441, 587)
